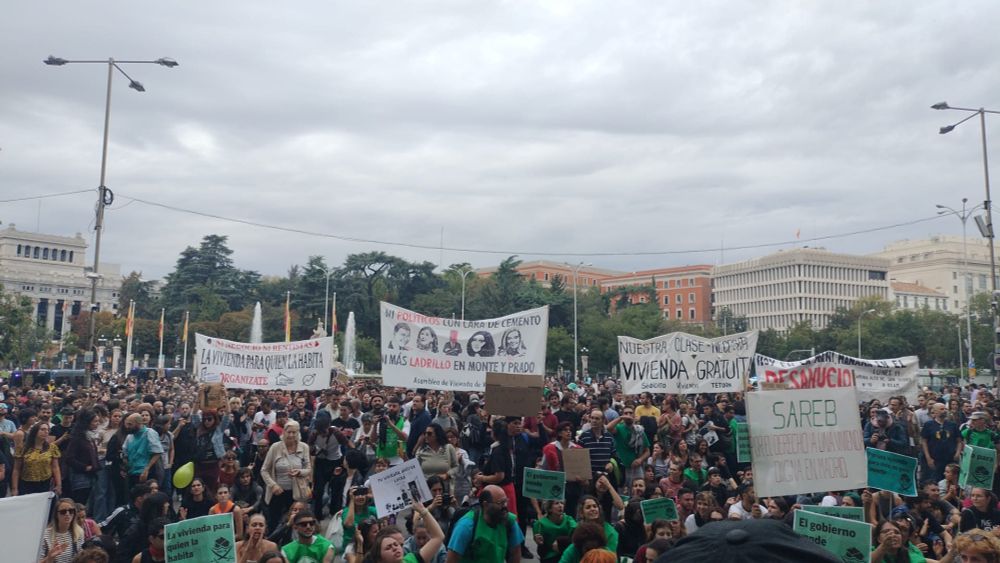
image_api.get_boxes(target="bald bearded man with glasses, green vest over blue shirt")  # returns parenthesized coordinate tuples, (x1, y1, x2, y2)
(447, 485, 524, 563)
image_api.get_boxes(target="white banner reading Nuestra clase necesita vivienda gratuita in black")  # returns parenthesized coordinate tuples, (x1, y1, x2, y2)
(618, 330, 758, 395)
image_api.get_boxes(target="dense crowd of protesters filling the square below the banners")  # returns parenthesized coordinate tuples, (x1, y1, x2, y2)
(0, 376, 1000, 563)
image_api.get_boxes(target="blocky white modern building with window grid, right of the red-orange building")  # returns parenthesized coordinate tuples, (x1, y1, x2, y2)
(712, 248, 889, 332)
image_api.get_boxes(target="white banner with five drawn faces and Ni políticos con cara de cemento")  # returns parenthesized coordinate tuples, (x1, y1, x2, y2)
(381, 301, 549, 392)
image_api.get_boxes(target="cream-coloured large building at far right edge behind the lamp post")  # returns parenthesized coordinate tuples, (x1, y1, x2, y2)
(872, 233, 1000, 313)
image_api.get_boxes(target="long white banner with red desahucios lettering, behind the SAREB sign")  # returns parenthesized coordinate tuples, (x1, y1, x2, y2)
(754, 352, 919, 402)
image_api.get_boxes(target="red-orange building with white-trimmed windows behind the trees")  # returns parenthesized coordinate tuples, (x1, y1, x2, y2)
(601, 265, 712, 324)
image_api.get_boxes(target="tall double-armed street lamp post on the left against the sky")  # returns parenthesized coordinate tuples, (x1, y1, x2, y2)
(42, 55, 177, 387)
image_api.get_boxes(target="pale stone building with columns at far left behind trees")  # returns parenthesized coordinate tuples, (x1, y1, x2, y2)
(0, 224, 122, 338)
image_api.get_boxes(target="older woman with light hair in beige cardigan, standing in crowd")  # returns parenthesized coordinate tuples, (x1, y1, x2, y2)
(260, 420, 312, 536)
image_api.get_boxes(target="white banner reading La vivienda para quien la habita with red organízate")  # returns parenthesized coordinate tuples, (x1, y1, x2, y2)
(194, 334, 333, 391)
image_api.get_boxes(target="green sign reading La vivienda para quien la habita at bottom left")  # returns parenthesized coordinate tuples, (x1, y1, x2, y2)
(169, 514, 236, 563)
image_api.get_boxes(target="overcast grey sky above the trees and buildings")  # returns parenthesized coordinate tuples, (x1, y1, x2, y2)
(0, 0, 1000, 279)
